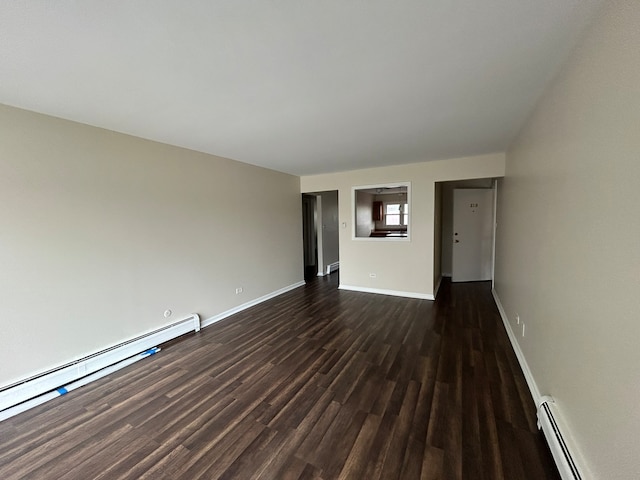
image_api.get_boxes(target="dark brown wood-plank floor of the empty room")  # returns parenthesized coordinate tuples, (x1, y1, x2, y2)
(0, 274, 559, 480)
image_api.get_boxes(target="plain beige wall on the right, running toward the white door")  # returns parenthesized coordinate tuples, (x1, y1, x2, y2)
(496, 0, 640, 480)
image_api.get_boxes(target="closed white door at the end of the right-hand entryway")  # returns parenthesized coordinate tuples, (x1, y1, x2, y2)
(451, 188, 493, 282)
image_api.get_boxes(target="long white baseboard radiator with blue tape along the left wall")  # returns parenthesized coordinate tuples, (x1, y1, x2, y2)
(0, 313, 200, 421)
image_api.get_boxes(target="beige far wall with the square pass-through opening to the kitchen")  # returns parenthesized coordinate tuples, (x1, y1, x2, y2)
(300, 154, 504, 296)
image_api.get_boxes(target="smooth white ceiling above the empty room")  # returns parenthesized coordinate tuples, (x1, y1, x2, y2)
(0, 0, 603, 175)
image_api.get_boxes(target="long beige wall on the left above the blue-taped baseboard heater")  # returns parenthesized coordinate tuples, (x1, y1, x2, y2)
(0, 106, 303, 385)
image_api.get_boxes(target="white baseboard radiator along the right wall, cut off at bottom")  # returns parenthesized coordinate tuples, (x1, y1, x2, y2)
(538, 396, 583, 480)
